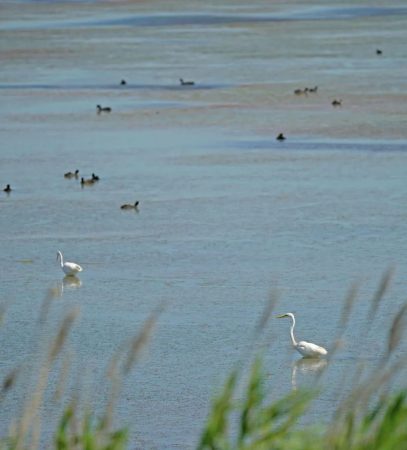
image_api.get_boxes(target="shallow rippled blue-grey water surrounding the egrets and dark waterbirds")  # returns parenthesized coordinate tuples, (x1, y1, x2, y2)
(0, 1, 407, 449)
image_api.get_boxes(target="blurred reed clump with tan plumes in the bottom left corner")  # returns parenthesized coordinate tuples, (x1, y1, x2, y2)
(0, 287, 164, 450)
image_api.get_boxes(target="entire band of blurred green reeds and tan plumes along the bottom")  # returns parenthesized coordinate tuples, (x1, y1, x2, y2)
(0, 271, 407, 450)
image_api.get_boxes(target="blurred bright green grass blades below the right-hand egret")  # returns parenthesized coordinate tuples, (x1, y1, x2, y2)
(198, 359, 407, 450)
